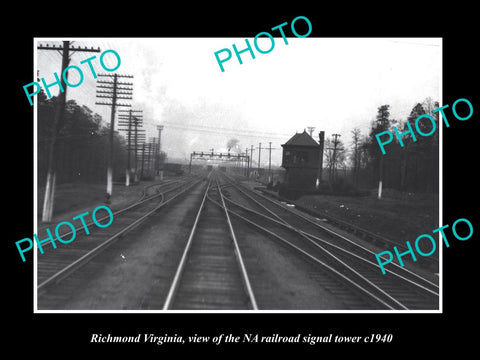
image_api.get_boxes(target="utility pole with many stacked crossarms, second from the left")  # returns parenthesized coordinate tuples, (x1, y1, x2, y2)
(95, 74, 133, 203)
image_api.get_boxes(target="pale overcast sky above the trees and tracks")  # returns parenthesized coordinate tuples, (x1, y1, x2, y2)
(36, 38, 442, 164)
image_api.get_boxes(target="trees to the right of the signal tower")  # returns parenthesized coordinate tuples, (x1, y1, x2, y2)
(324, 98, 439, 193)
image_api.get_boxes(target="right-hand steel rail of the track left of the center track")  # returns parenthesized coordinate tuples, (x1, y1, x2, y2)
(37, 180, 201, 291)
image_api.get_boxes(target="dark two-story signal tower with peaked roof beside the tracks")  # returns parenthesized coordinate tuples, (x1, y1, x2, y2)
(282, 130, 323, 190)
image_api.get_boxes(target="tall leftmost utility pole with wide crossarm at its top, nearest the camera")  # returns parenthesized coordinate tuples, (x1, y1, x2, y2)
(37, 41, 100, 222)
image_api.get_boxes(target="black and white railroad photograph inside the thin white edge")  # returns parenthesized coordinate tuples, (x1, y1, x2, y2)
(33, 37, 442, 311)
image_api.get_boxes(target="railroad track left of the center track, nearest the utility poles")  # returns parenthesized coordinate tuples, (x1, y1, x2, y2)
(36, 178, 202, 299)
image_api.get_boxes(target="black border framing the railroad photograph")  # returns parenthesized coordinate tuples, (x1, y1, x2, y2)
(6, 3, 480, 357)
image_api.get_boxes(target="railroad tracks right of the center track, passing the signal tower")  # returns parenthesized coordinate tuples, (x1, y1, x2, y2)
(216, 171, 439, 310)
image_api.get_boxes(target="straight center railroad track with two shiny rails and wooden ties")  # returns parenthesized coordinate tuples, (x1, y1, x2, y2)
(163, 175, 257, 310)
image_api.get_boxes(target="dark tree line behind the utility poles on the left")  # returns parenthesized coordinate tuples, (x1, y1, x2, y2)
(37, 96, 127, 186)
